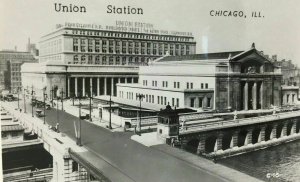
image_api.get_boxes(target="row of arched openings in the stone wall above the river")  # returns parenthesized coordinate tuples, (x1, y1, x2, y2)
(197, 121, 297, 154)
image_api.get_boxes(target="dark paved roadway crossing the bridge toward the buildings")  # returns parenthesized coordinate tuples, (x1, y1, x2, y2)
(16, 101, 226, 182)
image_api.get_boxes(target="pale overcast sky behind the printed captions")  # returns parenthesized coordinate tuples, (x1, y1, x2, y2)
(0, 0, 300, 65)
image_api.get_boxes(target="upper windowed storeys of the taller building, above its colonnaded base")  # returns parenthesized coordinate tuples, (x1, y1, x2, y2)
(40, 23, 196, 65)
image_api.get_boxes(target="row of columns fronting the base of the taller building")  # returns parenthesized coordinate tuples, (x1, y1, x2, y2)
(67, 77, 135, 97)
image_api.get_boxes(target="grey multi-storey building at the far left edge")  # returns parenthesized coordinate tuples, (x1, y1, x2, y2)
(0, 50, 37, 93)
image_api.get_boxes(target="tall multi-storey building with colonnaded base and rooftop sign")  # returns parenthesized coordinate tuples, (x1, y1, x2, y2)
(22, 23, 196, 100)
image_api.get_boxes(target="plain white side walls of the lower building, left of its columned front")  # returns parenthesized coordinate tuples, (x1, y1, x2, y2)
(117, 61, 216, 109)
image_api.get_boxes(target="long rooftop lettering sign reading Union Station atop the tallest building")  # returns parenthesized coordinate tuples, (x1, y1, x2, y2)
(56, 20, 193, 37)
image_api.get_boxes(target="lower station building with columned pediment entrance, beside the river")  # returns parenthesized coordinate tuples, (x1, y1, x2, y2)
(117, 44, 282, 111)
